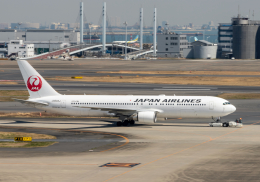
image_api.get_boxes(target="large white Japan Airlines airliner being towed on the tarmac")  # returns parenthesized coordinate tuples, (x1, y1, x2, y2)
(15, 60, 236, 126)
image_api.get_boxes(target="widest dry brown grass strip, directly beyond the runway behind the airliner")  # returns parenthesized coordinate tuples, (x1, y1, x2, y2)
(49, 75, 260, 86)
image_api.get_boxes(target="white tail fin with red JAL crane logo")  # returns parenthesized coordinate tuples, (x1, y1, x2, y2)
(17, 60, 60, 98)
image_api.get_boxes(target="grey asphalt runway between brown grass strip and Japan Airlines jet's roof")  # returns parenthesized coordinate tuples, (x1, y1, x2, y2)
(0, 81, 260, 96)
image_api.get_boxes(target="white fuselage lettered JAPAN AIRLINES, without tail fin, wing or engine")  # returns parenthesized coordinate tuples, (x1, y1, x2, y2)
(29, 95, 236, 118)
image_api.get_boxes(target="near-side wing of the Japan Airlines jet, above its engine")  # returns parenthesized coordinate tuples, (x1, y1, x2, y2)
(73, 106, 163, 116)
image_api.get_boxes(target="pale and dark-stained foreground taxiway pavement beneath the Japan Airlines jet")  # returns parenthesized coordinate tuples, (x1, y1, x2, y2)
(0, 100, 260, 182)
